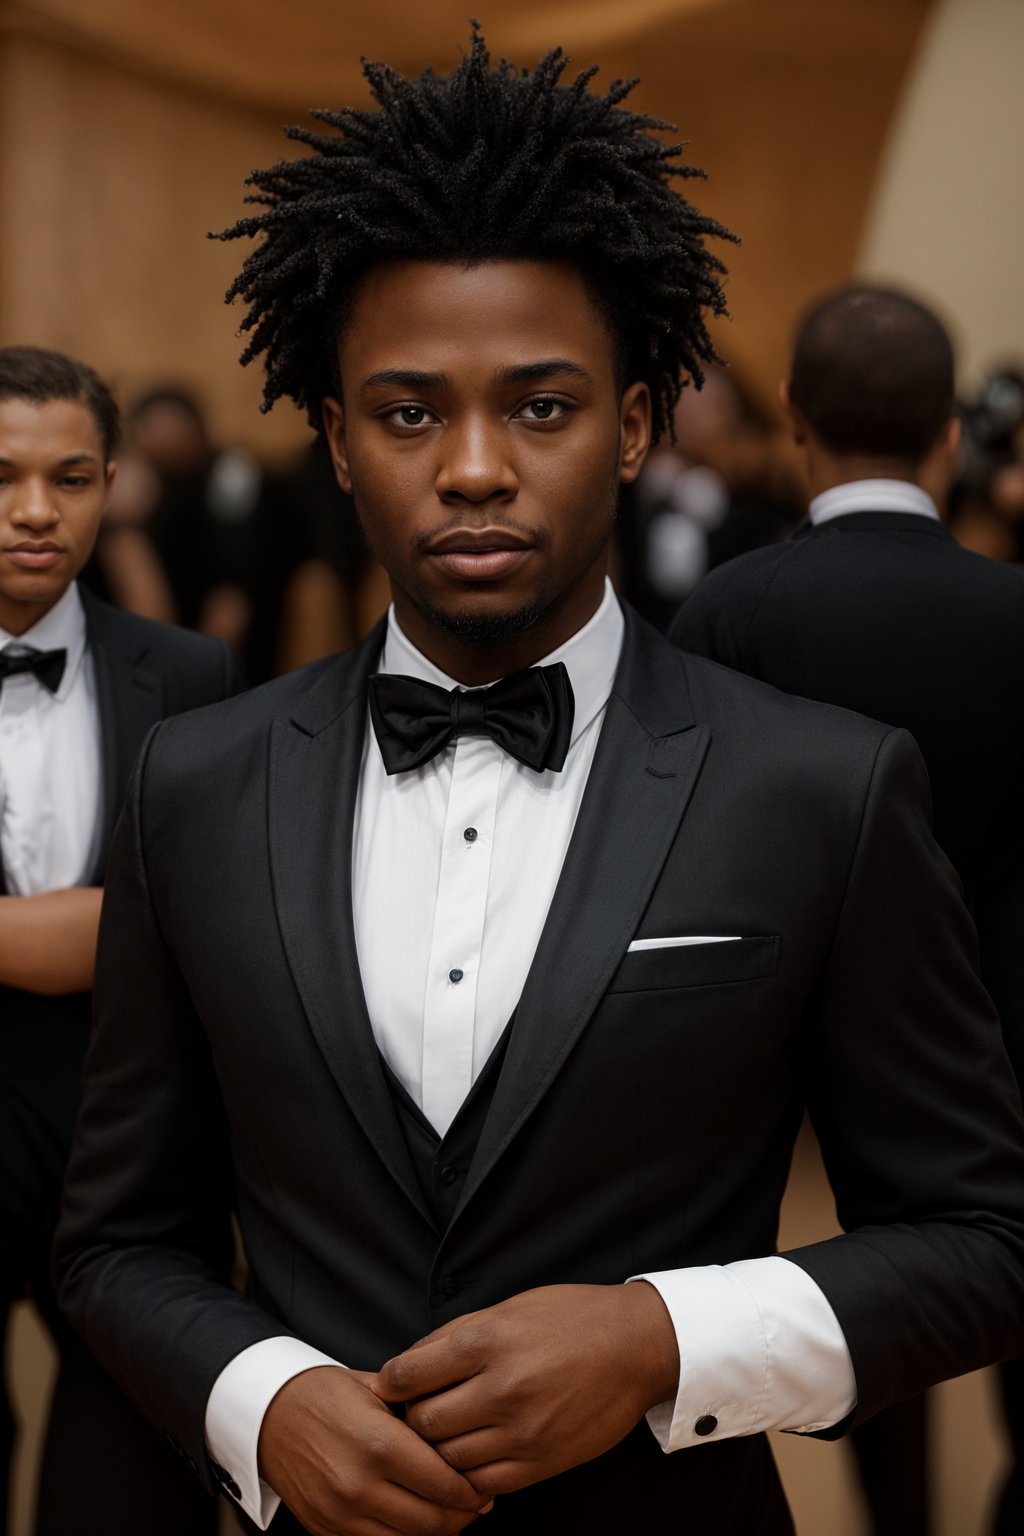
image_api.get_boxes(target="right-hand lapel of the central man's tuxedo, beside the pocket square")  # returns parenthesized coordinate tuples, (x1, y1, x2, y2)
(456, 610, 709, 1215)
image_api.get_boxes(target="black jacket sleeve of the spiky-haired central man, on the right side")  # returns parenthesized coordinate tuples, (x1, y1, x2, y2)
(785, 731, 1024, 1436)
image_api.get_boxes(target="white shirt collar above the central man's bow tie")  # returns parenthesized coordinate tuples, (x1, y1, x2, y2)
(378, 578, 625, 742)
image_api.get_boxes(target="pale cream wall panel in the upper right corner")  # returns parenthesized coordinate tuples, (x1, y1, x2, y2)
(858, 0, 1024, 381)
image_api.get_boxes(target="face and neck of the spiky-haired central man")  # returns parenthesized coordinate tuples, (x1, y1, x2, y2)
(324, 261, 651, 684)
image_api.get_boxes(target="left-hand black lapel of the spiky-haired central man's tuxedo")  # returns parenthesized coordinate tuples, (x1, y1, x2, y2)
(269, 625, 430, 1220)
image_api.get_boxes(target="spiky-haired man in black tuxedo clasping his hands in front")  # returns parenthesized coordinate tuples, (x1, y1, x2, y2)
(58, 31, 1024, 1536)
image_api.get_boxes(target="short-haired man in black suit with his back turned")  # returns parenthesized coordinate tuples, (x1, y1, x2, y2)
(671, 287, 1024, 1536)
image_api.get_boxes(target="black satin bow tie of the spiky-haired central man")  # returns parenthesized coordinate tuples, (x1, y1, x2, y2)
(370, 662, 573, 774)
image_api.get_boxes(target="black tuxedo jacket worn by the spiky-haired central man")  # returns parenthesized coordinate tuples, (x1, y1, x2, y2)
(58, 614, 1024, 1536)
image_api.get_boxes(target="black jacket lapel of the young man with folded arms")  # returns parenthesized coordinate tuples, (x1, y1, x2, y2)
(78, 588, 166, 882)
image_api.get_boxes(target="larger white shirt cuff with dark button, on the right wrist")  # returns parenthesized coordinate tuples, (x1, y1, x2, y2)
(633, 1256, 857, 1452)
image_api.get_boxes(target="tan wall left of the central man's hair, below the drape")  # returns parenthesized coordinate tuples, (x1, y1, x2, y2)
(0, 38, 304, 452)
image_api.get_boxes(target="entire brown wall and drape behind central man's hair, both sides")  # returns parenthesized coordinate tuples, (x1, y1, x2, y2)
(0, 0, 927, 452)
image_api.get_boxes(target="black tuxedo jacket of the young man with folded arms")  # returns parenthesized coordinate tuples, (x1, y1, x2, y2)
(0, 588, 239, 1289)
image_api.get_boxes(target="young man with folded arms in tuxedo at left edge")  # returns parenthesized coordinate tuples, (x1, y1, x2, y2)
(0, 347, 236, 1536)
